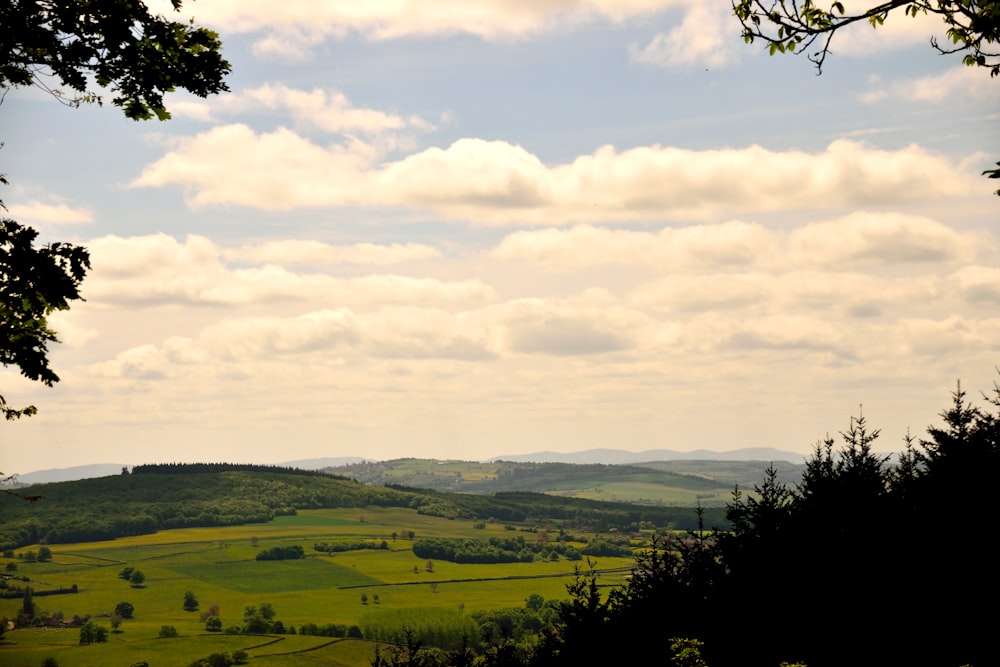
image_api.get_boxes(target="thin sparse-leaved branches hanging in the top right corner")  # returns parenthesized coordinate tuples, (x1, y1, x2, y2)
(733, 0, 1000, 76)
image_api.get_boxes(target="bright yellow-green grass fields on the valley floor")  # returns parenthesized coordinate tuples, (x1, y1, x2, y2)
(0, 508, 633, 667)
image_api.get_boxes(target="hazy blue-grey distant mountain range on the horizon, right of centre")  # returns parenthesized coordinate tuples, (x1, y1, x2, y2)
(488, 447, 806, 465)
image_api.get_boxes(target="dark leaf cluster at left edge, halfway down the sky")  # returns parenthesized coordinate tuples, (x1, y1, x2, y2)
(0, 218, 90, 420)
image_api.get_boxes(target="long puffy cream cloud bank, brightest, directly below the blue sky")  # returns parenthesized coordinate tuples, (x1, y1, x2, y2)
(131, 130, 985, 225)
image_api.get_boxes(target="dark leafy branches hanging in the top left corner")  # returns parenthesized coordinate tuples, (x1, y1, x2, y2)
(0, 0, 230, 120)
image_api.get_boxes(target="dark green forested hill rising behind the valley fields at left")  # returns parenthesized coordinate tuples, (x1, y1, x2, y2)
(0, 464, 725, 549)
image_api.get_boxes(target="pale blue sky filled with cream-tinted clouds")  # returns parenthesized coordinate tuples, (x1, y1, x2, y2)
(0, 0, 1000, 474)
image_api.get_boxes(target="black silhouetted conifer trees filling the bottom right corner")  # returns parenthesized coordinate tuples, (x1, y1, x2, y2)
(535, 378, 1000, 667)
